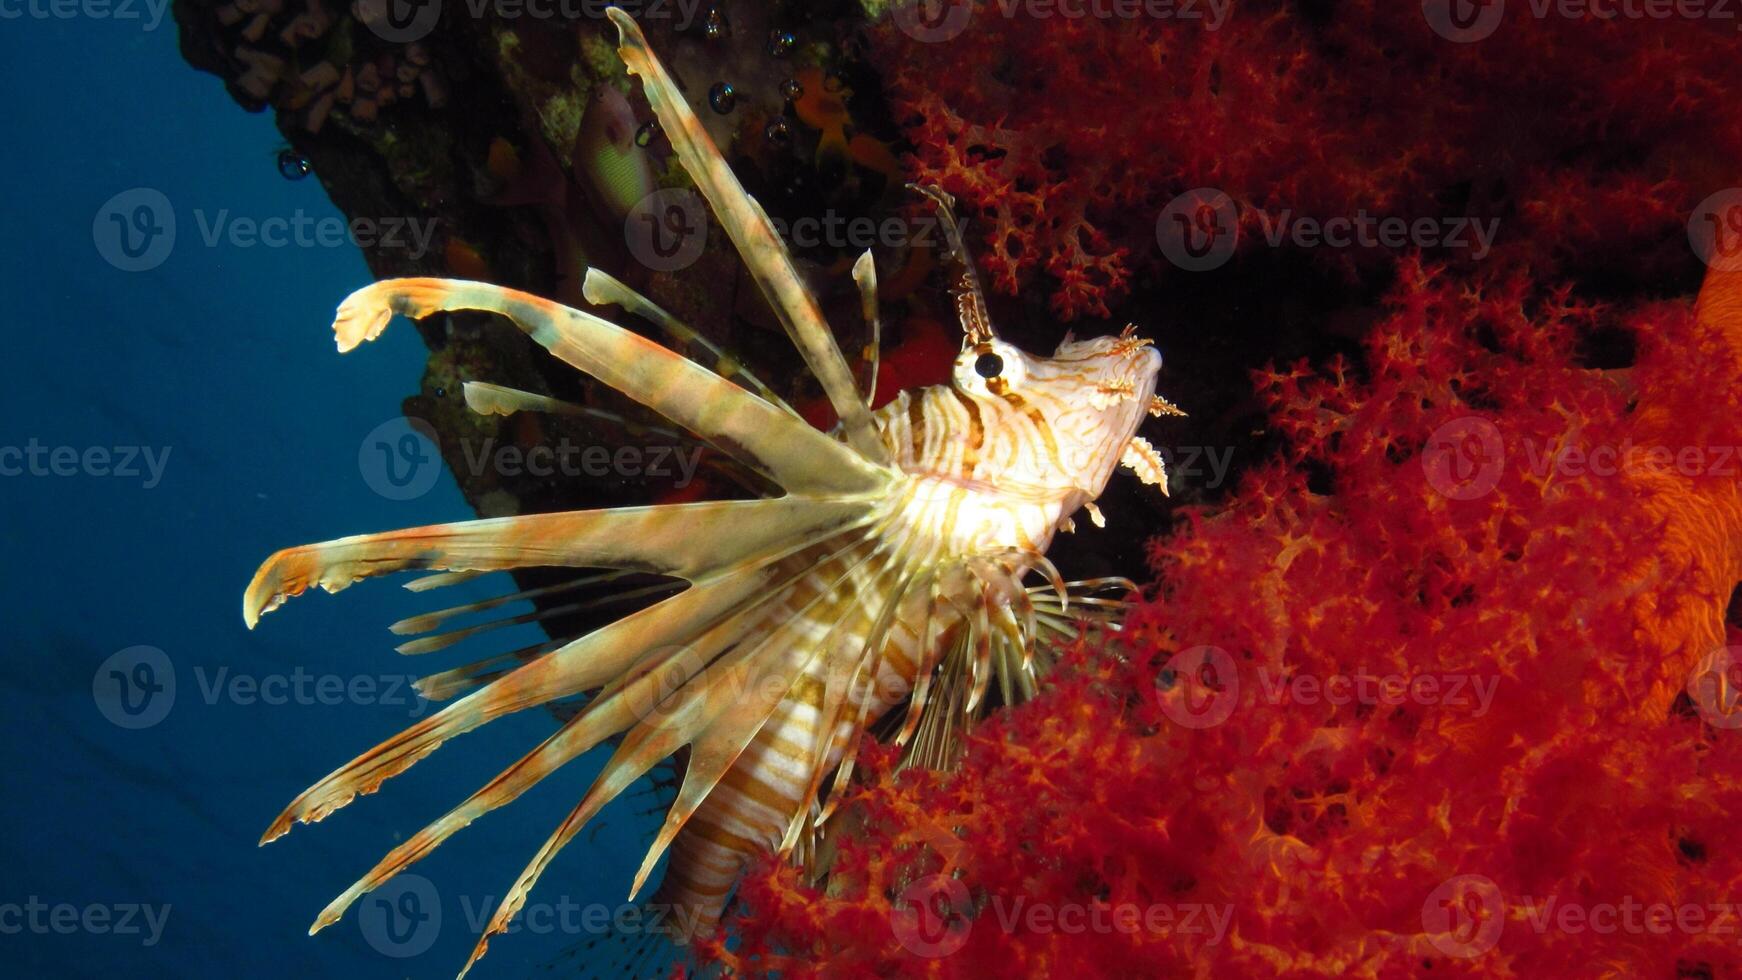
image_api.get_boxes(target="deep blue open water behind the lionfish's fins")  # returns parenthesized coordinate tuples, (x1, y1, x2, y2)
(0, 14, 650, 978)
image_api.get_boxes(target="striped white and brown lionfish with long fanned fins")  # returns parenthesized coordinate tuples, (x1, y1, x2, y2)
(242, 7, 1181, 975)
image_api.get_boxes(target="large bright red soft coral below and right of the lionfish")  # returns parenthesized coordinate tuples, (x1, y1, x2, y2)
(709, 265, 1742, 977)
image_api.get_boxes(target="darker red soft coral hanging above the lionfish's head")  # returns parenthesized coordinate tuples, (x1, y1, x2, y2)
(873, 0, 1742, 319)
